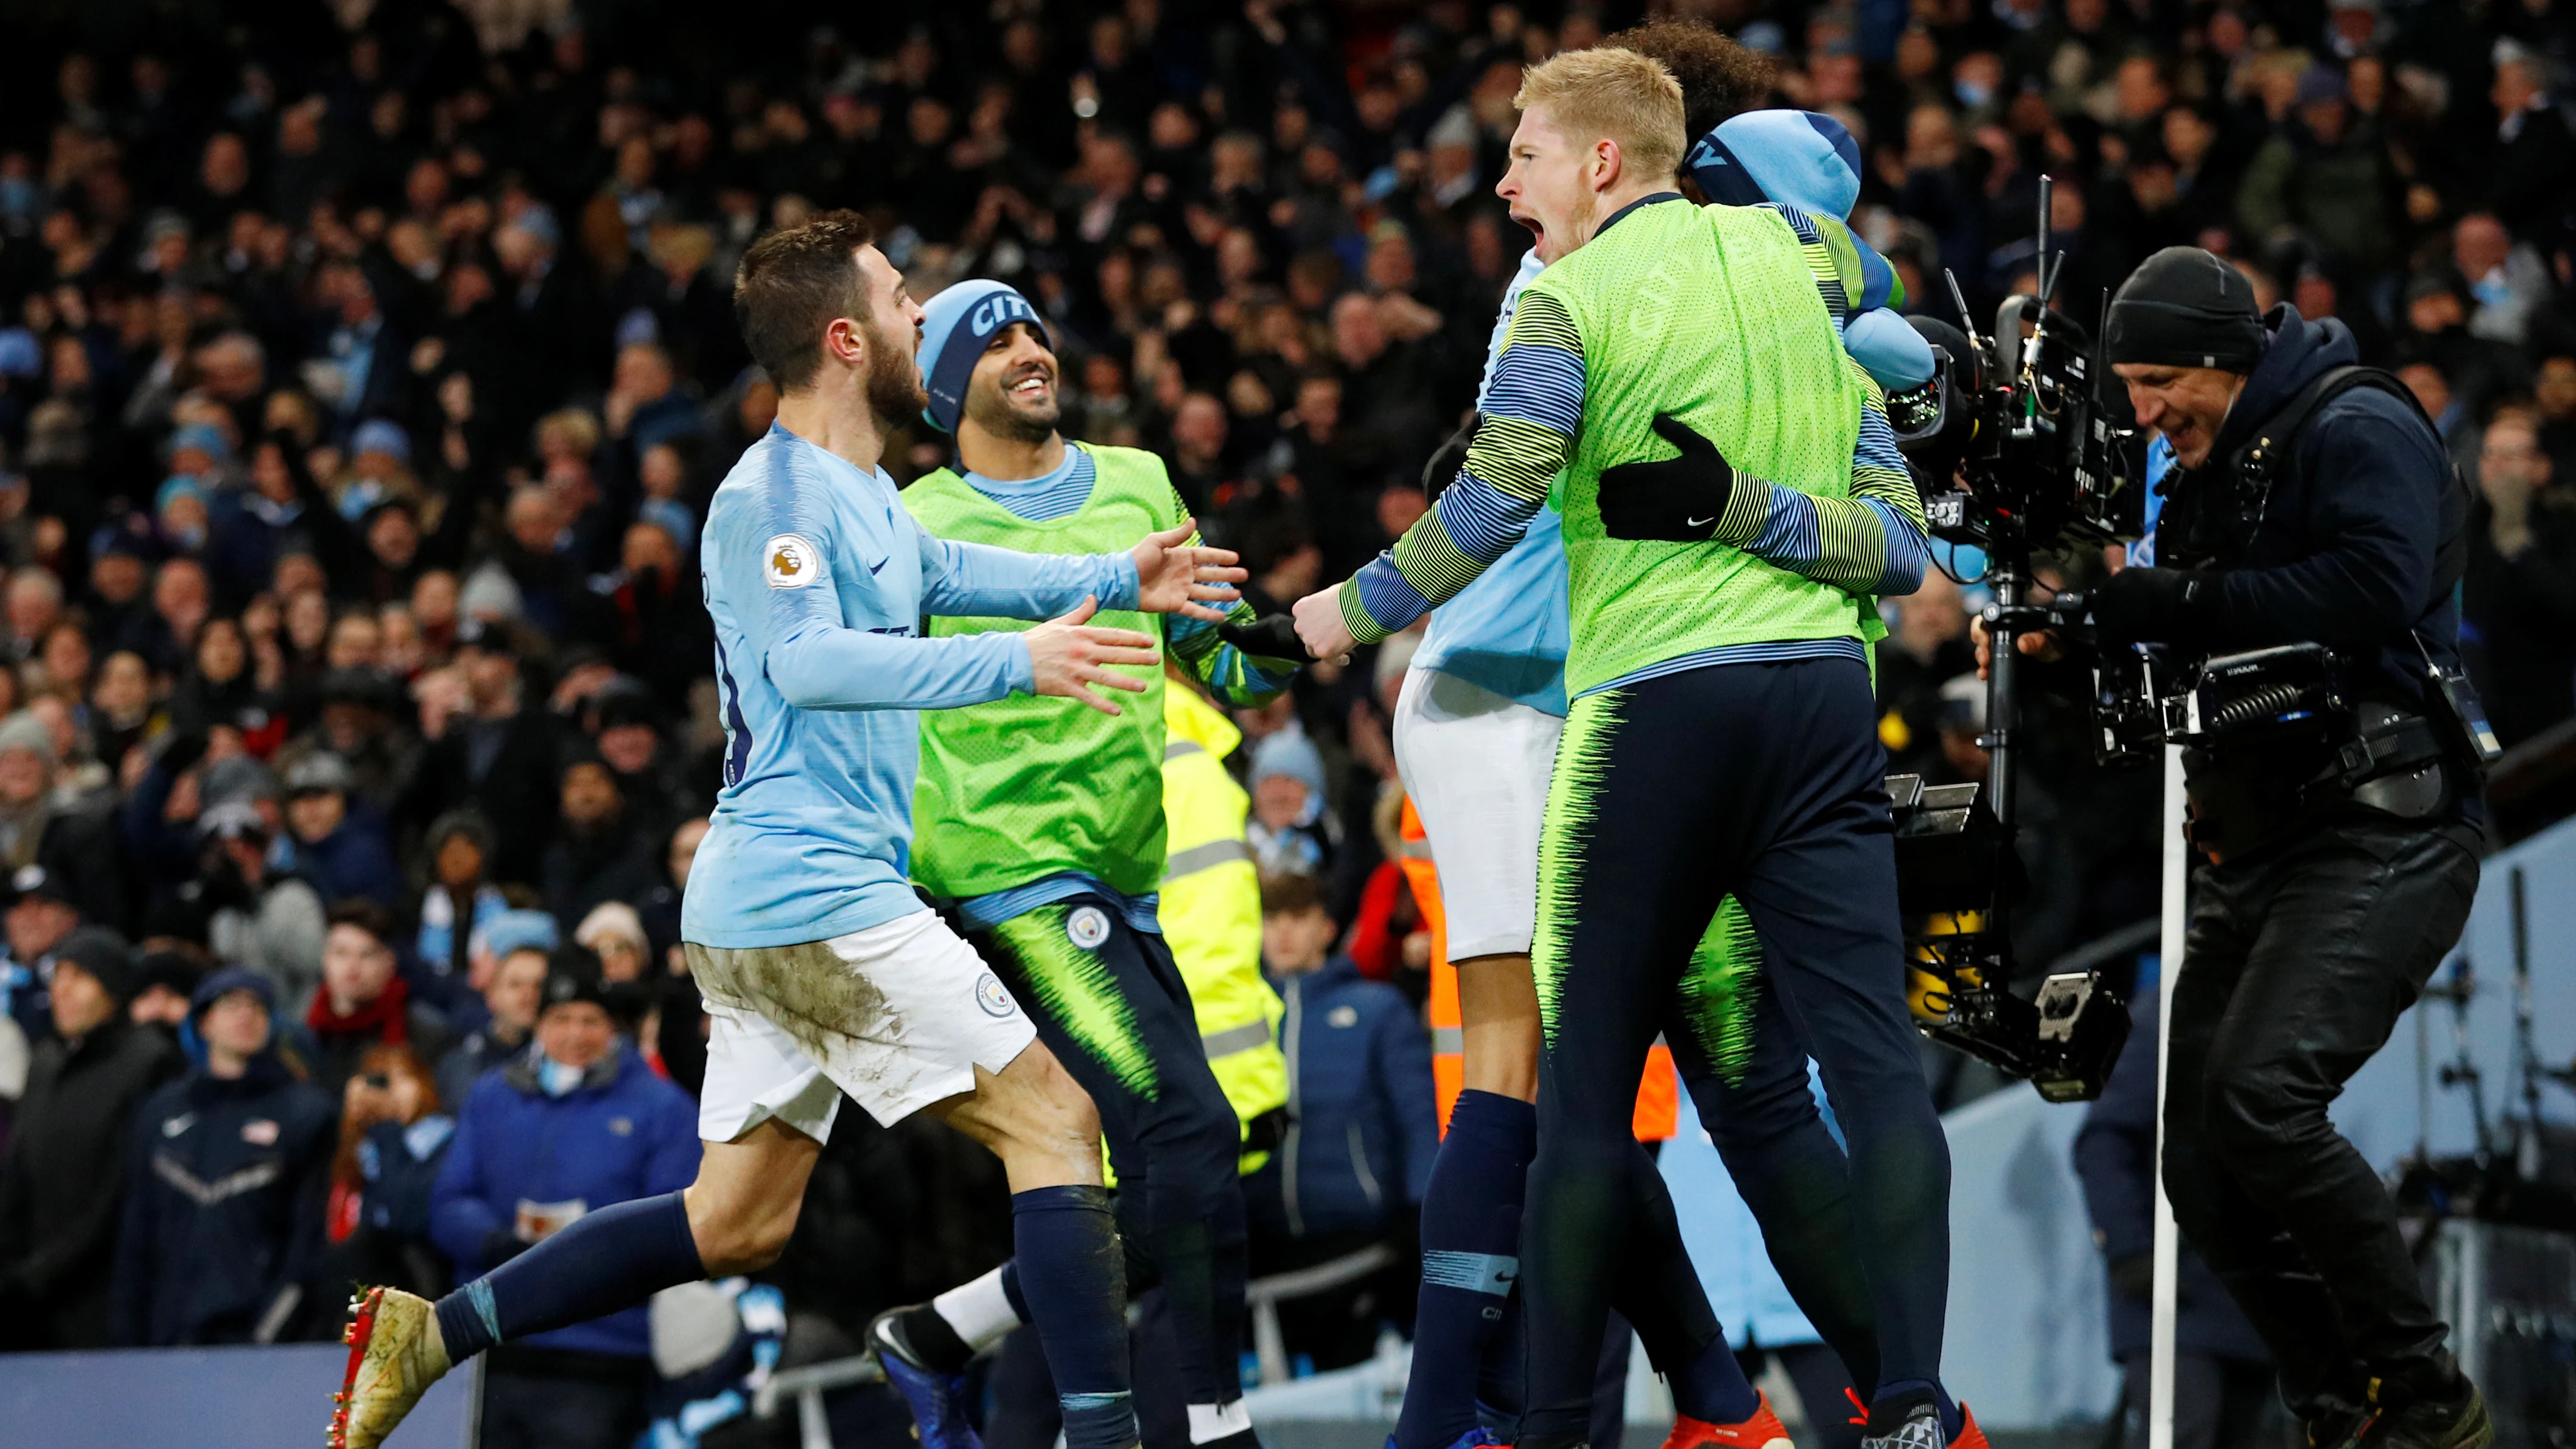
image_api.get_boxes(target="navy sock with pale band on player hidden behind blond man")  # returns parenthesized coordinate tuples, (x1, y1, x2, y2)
(1396, 1091, 1538, 1449)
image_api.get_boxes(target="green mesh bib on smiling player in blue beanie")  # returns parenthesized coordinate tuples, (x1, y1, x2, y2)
(904, 442, 1182, 898)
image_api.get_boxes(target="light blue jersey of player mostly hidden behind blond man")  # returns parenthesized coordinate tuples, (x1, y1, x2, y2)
(1414, 247, 1572, 716)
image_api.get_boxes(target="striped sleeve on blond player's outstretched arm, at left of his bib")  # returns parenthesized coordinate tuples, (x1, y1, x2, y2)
(1342, 288, 1584, 643)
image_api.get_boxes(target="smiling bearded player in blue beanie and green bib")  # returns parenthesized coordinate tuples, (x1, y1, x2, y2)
(868, 281, 1298, 1449)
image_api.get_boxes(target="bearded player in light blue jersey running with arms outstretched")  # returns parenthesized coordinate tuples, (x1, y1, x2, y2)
(330, 211, 1244, 1449)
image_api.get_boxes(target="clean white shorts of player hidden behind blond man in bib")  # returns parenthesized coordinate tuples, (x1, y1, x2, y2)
(1396, 669, 1566, 960)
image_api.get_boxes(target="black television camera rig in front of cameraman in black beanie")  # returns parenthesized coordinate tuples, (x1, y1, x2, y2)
(1888, 175, 2135, 1102)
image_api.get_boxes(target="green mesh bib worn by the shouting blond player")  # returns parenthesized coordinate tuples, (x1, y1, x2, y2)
(1522, 206, 1865, 695)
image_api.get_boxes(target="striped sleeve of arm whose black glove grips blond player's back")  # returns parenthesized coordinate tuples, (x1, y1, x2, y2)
(1716, 358, 1932, 595)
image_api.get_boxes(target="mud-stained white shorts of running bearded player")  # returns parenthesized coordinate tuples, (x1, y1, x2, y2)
(688, 911, 1038, 1143)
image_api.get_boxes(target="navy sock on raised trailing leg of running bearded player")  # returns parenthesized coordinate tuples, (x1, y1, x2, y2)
(438, 1192, 706, 1364)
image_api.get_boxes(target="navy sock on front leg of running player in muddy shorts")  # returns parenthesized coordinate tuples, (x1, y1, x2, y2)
(1004, 1187, 1136, 1449)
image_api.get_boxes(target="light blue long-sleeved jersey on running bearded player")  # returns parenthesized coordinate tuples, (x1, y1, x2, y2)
(680, 425, 1136, 950)
